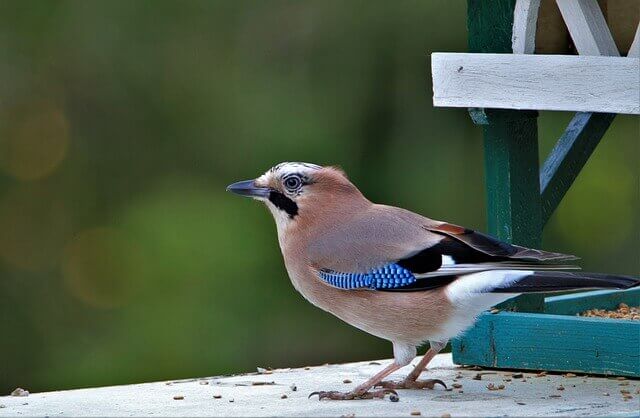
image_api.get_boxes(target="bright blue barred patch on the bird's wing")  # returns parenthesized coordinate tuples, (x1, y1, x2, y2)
(318, 264, 416, 289)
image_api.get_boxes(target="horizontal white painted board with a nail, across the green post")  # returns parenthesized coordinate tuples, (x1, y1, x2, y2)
(431, 53, 640, 114)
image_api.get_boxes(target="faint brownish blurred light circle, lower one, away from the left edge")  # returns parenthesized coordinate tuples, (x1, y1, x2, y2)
(62, 227, 137, 308)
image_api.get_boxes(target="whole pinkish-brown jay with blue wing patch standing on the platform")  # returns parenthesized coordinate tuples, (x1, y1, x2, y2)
(227, 162, 640, 400)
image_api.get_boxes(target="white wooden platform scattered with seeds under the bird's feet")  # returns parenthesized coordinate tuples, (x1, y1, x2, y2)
(0, 354, 640, 417)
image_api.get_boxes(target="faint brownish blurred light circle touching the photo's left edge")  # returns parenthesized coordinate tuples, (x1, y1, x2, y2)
(0, 101, 69, 180)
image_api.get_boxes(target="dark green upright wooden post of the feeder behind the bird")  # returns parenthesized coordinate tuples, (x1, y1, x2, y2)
(467, 0, 544, 312)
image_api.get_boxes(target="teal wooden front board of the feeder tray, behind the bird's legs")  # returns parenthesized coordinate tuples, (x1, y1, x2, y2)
(452, 312, 640, 377)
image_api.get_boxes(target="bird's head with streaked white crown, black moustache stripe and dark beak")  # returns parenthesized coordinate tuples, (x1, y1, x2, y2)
(227, 162, 368, 230)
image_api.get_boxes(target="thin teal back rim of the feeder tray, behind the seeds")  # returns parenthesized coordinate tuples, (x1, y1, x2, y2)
(544, 288, 640, 315)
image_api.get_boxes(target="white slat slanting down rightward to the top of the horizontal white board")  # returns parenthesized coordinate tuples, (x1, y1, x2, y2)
(556, 0, 620, 56)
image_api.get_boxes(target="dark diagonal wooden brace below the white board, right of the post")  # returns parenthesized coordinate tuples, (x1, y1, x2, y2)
(540, 112, 616, 225)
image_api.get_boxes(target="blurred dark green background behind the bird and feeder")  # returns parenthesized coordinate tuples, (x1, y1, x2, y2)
(0, 0, 640, 394)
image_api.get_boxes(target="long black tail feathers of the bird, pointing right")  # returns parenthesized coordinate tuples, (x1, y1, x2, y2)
(493, 271, 640, 293)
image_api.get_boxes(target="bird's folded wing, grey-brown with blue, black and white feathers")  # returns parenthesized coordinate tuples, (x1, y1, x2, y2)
(309, 205, 576, 290)
